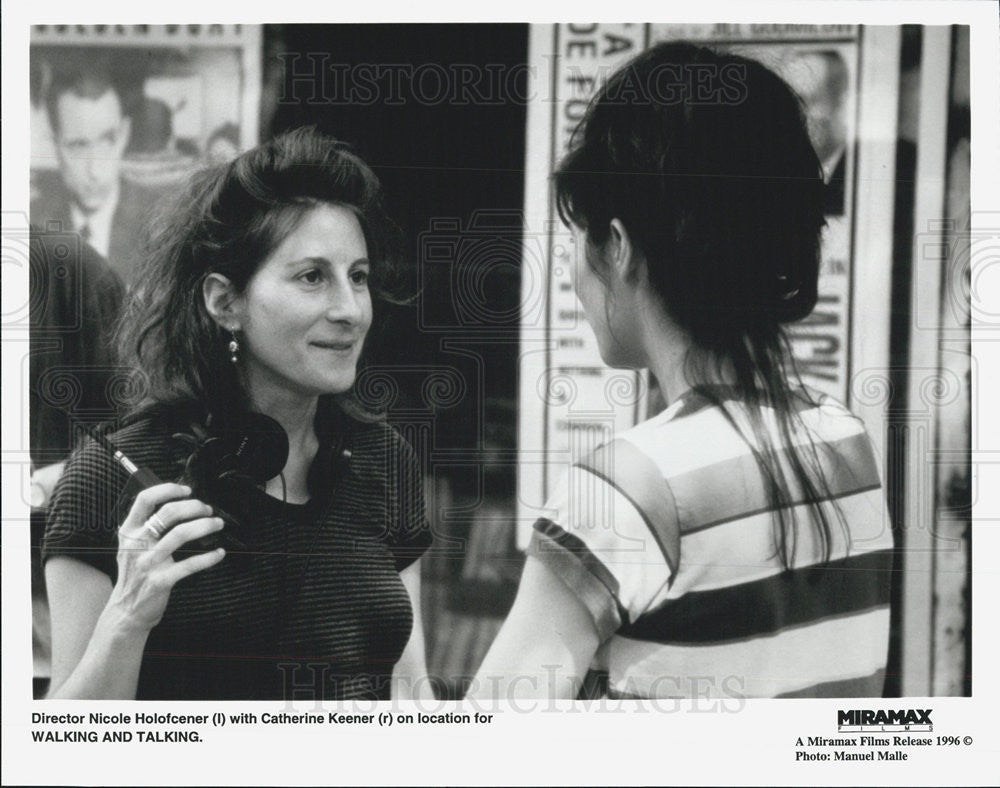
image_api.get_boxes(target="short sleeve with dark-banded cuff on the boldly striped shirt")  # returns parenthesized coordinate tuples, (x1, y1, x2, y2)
(528, 440, 680, 641)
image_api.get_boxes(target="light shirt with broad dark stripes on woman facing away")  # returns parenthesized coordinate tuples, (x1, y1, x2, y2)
(530, 387, 893, 698)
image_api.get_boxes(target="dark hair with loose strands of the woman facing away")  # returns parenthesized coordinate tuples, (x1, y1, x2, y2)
(554, 42, 844, 569)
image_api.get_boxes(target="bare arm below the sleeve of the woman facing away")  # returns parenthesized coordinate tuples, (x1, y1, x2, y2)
(467, 557, 600, 700)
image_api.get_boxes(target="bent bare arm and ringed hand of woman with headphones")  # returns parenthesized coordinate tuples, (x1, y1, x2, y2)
(45, 484, 224, 699)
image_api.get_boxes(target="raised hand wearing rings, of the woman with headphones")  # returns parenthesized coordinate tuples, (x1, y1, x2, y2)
(106, 484, 225, 632)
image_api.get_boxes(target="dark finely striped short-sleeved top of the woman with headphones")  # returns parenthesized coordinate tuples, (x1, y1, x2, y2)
(43, 406, 430, 700)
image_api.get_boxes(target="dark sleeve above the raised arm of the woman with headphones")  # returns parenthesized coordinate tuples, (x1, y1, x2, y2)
(42, 439, 127, 583)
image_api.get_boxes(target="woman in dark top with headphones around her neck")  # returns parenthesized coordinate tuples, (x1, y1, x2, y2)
(44, 129, 430, 699)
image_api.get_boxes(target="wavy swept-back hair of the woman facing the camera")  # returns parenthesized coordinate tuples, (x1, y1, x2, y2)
(118, 127, 399, 426)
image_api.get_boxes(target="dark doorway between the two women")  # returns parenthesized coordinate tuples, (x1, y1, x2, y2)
(261, 24, 528, 696)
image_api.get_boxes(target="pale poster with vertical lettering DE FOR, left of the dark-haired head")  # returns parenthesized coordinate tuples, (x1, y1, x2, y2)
(518, 24, 650, 546)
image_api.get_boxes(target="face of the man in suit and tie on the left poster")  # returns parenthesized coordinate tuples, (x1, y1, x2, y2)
(55, 89, 130, 212)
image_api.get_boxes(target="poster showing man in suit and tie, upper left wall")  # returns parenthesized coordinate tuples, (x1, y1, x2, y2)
(29, 24, 261, 283)
